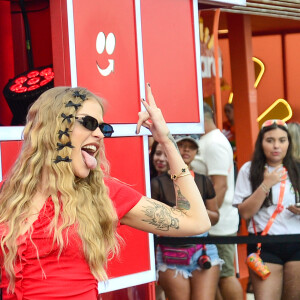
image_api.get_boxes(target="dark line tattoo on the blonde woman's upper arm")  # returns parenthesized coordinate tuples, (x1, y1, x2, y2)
(143, 199, 183, 231)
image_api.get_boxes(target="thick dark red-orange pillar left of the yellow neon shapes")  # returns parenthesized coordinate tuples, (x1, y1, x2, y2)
(227, 14, 258, 168)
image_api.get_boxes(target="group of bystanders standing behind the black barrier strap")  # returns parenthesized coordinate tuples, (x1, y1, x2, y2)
(150, 103, 300, 300)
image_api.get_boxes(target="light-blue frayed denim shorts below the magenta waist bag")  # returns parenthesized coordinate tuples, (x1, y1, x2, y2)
(156, 244, 224, 279)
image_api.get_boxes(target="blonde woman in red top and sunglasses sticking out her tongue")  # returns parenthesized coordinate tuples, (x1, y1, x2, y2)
(0, 85, 210, 300)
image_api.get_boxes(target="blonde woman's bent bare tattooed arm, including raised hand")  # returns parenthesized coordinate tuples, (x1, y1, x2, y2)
(121, 86, 211, 236)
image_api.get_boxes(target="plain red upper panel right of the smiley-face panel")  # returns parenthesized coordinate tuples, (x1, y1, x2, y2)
(141, 0, 201, 122)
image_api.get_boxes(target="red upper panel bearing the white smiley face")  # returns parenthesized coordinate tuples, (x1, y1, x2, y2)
(74, 0, 140, 123)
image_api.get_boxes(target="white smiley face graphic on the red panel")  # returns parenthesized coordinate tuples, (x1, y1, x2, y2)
(96, 32, 116, 76)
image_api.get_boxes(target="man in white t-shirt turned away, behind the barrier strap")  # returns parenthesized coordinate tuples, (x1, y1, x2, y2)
(192, 103, 243, 300)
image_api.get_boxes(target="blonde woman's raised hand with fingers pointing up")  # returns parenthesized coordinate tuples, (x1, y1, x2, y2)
(136, 83, 170, 143)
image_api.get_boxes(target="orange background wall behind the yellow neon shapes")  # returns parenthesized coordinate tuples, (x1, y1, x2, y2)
(219, 34, 300, 122)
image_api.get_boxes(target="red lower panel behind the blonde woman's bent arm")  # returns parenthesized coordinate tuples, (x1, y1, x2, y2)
(105, 137, 150, 277)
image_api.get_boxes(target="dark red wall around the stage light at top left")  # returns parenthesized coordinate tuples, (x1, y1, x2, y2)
(0, 0, 52, 126)
